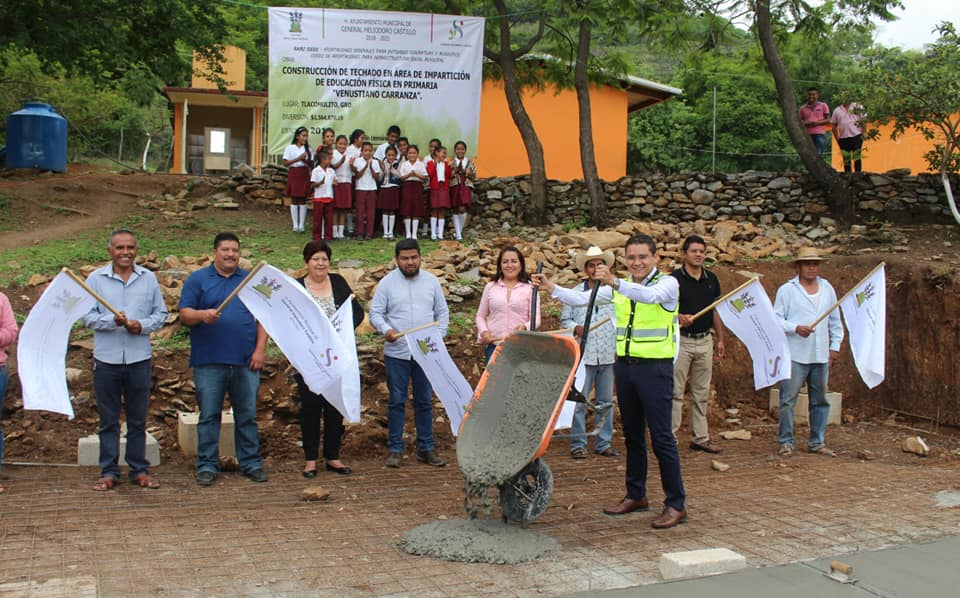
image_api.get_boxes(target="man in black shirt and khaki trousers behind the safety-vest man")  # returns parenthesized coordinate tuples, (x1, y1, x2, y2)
(672, 235, 725, 454)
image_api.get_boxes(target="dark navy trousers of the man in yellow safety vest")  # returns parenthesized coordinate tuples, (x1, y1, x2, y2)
(613, 359, 686, 511)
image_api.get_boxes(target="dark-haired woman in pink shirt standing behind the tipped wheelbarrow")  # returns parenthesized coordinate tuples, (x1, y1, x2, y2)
(477, 247, 540, 361)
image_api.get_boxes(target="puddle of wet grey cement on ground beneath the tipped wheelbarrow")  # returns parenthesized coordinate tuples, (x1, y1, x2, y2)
(400, 519, 560, 565)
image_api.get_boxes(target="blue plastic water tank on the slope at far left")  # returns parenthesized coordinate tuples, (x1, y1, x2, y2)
(7, 102, 67, 172)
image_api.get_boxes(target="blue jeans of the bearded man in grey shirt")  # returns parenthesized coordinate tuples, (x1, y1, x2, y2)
(383, 355, 434, 453)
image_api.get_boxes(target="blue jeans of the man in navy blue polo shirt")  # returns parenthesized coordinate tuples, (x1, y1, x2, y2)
(193, 364, 263, 473)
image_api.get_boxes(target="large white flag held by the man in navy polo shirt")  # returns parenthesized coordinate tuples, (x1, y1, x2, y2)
(237, 264, 346, 394)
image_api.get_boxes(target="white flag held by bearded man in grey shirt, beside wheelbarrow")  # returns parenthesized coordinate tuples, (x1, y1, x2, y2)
(404, 326, 473, 436)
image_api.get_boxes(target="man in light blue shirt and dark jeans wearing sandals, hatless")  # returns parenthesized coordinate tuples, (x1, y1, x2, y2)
(83, 229, 167, 491)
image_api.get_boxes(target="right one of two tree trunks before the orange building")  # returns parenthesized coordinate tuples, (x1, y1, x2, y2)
(573, 18, 607, 228)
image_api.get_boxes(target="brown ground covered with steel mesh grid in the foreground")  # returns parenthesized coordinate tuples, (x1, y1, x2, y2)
(0, 440, 960, 598)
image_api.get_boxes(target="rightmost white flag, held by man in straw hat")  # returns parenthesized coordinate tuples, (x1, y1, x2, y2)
(840, 265, 887, 388)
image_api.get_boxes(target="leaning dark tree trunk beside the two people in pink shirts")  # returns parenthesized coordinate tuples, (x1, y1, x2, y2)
(756, 0, 853, 222)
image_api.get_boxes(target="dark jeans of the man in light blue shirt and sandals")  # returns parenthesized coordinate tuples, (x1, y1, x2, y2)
(93, 359, 151, 480)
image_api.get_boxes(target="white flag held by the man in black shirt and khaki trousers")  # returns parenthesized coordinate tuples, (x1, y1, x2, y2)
(716, 280, 790, 390)
